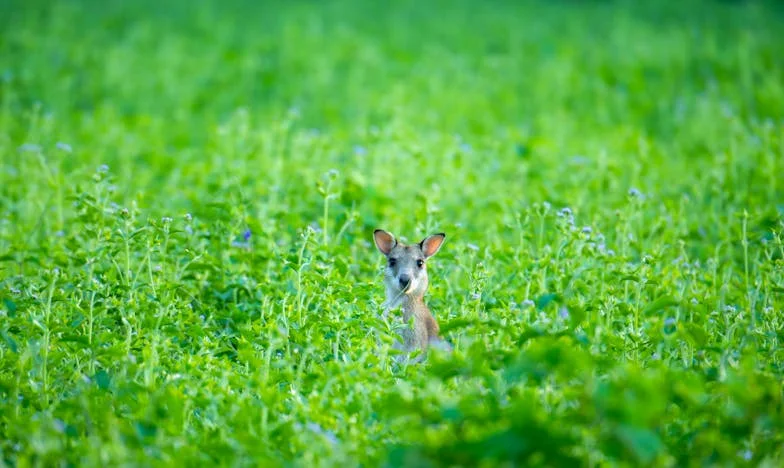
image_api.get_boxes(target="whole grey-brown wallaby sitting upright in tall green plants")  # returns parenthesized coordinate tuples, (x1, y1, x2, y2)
(373, 229, 451, 358)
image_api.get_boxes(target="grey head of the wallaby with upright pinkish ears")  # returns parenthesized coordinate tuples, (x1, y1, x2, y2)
(373, 229, 446, 307)
